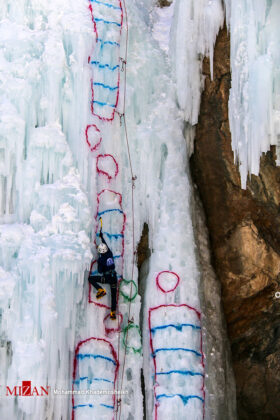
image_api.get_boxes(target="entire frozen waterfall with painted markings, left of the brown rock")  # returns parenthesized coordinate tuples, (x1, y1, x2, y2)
(0, 0, 238, 420)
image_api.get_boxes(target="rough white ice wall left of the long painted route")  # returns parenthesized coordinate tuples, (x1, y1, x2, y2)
(0, 0, 92, 419)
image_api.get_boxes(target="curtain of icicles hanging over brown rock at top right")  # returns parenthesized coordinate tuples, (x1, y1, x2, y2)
(225, 0, 280, 188)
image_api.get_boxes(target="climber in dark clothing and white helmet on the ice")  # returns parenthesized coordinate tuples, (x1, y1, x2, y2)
(88, 228, 118, 319)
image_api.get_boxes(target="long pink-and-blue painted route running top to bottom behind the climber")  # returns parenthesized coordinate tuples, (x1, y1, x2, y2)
(72, 0, 126, 420)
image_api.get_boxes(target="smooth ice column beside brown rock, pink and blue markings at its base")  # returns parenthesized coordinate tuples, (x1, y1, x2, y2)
(123, 1, 220, 419)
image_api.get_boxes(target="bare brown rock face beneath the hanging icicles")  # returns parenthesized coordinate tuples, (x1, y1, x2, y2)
(191, 28, 280, 420)
